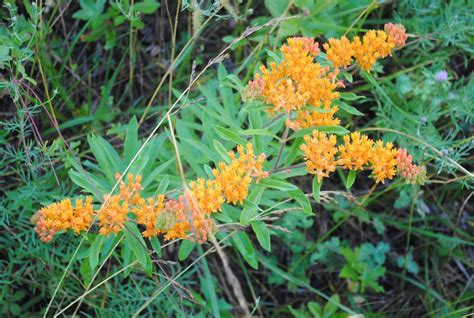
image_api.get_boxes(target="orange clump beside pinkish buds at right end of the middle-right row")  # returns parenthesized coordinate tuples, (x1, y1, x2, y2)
(370, 140, 398, 183)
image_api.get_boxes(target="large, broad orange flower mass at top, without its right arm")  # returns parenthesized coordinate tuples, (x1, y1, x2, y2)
(243, 37, 341, 130)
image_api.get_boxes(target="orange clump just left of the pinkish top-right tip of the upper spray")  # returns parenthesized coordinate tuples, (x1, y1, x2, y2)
(352, 30, 395, 71)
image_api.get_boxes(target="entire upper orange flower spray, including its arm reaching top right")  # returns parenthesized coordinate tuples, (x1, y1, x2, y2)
(242, 23, 407, 135)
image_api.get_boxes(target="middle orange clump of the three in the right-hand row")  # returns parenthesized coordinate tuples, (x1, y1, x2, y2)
(339, 132, 374, 170)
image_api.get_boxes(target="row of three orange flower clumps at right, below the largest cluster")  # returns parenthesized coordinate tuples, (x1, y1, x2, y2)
(301, 130, 412, 183)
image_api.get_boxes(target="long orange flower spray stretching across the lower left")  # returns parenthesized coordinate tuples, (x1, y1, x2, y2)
(32, 144, 268, 242)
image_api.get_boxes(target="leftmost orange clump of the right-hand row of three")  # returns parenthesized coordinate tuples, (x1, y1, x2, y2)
(301, 130, 337, 182)
